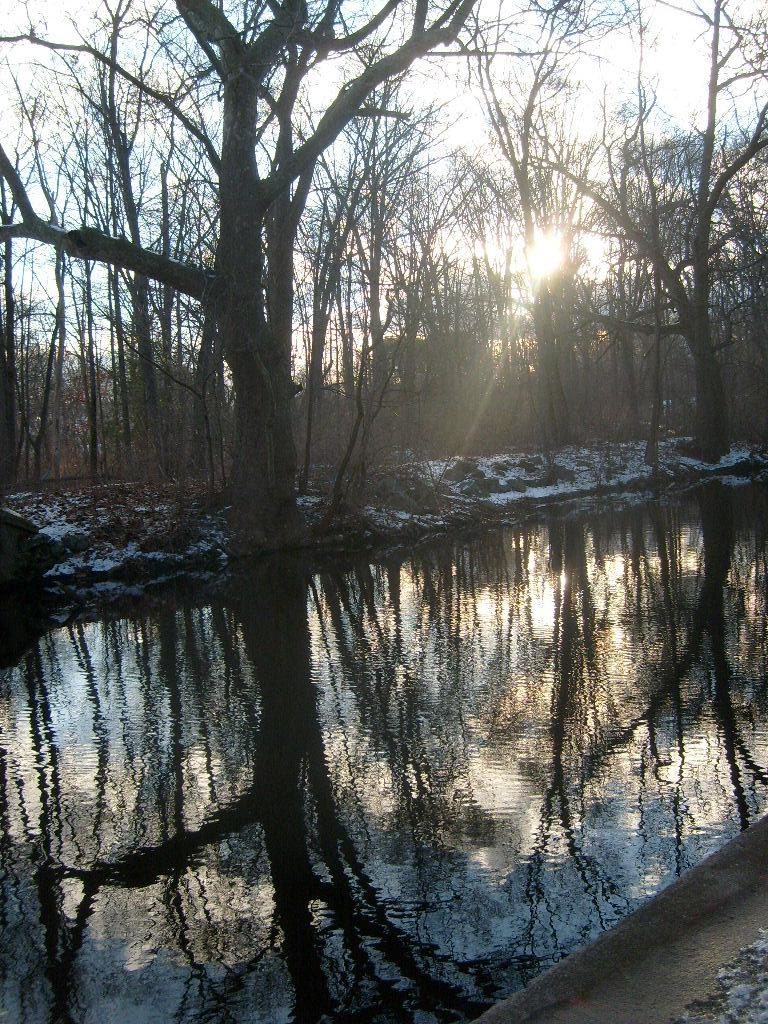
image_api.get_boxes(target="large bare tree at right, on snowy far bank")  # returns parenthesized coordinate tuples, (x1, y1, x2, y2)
(551, 0, 768, 461)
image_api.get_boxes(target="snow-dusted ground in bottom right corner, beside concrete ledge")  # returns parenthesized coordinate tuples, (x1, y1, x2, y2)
(676, 929, 768, 1024)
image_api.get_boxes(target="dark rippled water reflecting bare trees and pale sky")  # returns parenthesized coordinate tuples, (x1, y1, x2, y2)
(0, 485, 768, 1024)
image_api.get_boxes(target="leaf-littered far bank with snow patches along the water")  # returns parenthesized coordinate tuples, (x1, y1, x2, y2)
(5, 440, 768, 604)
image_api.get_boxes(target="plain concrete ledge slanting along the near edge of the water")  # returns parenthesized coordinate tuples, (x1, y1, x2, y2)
(478, 816, 768, 1024)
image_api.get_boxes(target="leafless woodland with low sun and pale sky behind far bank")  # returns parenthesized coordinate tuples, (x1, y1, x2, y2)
(0, 0, 768, 544)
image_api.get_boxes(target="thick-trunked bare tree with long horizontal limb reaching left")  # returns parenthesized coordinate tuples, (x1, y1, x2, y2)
(0, 0, 475, 543)
